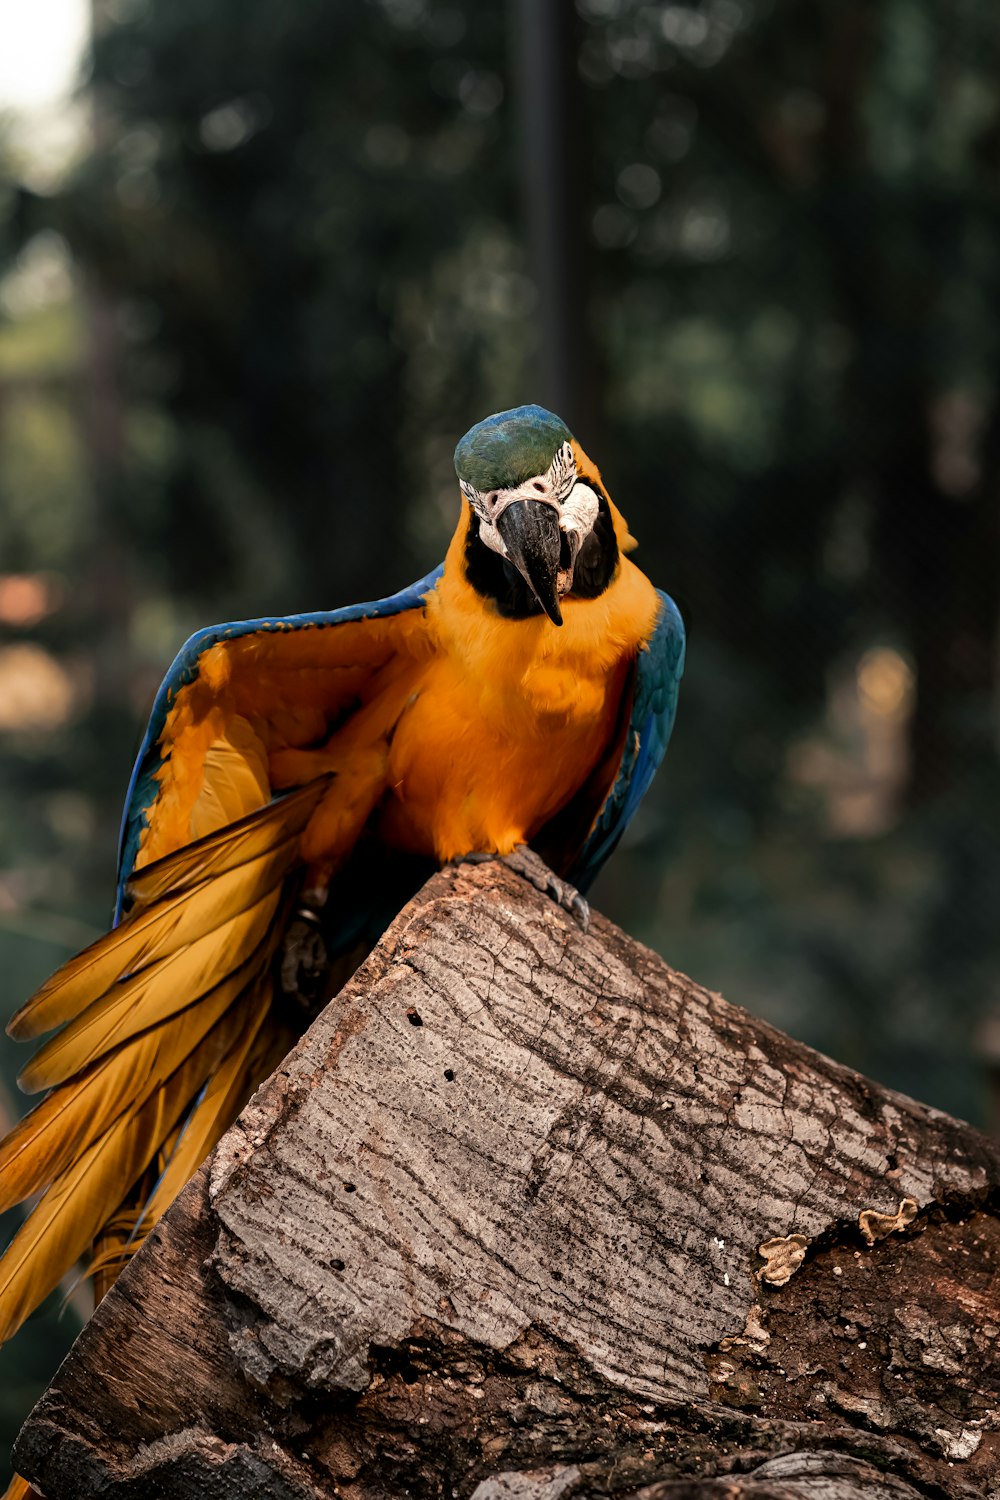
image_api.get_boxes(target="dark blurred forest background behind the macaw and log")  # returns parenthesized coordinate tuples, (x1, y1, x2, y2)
(0, 0, 1000, 1449)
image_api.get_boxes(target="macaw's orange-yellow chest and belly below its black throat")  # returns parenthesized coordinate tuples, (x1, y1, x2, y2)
(371, 537, 657, 860)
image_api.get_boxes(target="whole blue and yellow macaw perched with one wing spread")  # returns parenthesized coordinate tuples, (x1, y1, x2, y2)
(0, 407, 684, 1341)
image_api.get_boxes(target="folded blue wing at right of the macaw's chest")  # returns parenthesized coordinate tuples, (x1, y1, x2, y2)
(570, 590, 684, 891)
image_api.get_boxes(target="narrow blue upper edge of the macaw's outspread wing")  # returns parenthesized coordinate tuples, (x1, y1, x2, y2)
(115, 566, 444, 923)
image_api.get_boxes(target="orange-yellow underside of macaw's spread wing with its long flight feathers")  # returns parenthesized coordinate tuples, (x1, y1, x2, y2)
(0, 611, 423, 1341)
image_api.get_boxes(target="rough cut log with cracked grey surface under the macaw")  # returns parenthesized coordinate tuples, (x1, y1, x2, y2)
(15, 863, 1000, 1500)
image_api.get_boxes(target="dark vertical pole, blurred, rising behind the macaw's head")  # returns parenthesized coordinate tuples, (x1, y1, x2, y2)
(510, 0, 597, 444)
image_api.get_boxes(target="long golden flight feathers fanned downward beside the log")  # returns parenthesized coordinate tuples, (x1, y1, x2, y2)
(0, 777, 330, 1341)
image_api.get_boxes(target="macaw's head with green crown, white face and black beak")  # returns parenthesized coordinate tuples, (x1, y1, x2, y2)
(454, 407, 619, 626)
